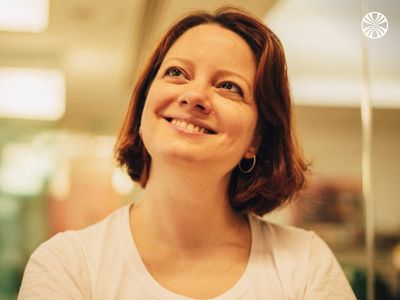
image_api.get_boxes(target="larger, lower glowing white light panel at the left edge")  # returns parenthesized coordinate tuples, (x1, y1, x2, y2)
(0, 68, 65, 121)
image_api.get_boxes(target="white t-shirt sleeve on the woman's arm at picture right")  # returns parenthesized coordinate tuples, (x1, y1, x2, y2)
(303, 233, 356, 300)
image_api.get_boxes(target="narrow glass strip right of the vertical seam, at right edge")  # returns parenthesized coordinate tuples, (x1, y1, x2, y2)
(365, 0, 400, 300)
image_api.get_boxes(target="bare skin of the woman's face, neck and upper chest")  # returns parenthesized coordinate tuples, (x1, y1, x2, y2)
(130, 24, 258, 298)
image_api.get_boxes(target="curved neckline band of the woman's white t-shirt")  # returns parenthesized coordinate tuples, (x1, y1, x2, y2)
(120, 204, 262, 300)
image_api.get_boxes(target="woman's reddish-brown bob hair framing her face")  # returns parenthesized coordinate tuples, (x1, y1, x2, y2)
(116, 7, 307, 215)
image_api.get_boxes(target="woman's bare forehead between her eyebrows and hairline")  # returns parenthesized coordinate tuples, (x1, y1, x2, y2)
(164, 24, 255, 73)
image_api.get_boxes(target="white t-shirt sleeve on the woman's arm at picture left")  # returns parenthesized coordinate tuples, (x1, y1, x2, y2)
(18, 232, 91, 300)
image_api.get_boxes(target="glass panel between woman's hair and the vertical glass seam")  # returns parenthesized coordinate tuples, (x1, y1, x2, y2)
(265, 1, 367, 299)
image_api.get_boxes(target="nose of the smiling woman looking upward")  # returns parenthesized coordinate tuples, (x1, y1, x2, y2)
(178, 87, 212, 114)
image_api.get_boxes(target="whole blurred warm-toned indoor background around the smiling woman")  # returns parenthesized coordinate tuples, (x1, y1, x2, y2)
(0, 0, 400, 300)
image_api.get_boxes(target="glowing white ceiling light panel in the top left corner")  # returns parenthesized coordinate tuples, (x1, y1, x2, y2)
(0, 0, 49, 32)
